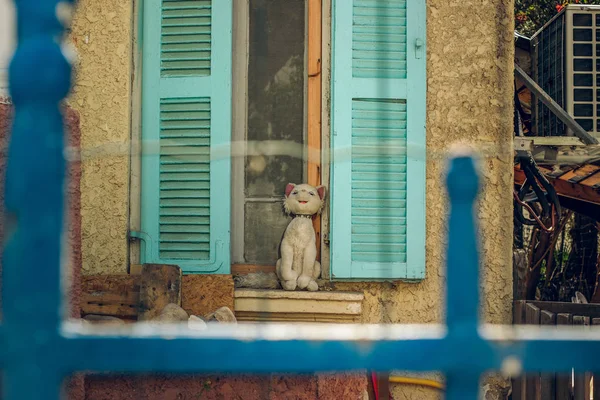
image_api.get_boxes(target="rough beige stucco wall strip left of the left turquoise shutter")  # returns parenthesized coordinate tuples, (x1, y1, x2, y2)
(69, 0, 133, 274)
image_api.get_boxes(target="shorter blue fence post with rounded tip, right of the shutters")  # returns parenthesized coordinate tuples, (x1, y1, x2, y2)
(446, 149, 485, 399)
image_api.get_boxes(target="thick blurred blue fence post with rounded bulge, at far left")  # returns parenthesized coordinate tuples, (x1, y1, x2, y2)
(2, 0, 72, 400)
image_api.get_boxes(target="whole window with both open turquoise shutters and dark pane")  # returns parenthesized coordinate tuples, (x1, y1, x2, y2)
(141, 0, 426, 280)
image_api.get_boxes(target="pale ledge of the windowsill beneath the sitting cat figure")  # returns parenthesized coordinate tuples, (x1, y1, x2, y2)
(234, 289, 364, 323)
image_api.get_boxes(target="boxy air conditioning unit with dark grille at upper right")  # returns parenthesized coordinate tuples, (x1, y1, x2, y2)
(531, 4, 600, 136)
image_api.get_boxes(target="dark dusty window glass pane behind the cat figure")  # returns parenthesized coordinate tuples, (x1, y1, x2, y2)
(244, 0, 305, 265)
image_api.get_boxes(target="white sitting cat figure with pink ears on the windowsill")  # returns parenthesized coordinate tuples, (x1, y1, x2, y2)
(276, 183, 325, 292)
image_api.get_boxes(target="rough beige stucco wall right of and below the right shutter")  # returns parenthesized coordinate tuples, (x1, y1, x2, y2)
(336, 0, 514, 399)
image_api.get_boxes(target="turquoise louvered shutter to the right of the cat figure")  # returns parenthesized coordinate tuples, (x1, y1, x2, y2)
(331, 0, 426, 279)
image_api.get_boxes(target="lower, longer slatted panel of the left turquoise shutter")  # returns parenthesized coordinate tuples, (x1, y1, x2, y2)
(159, 98, 210, 260)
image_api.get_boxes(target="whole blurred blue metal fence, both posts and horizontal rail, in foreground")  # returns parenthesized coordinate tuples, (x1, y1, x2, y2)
(0, 0, 600, 400)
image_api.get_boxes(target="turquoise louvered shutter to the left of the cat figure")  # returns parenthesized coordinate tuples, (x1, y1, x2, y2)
(141, 0, 232, 273)
